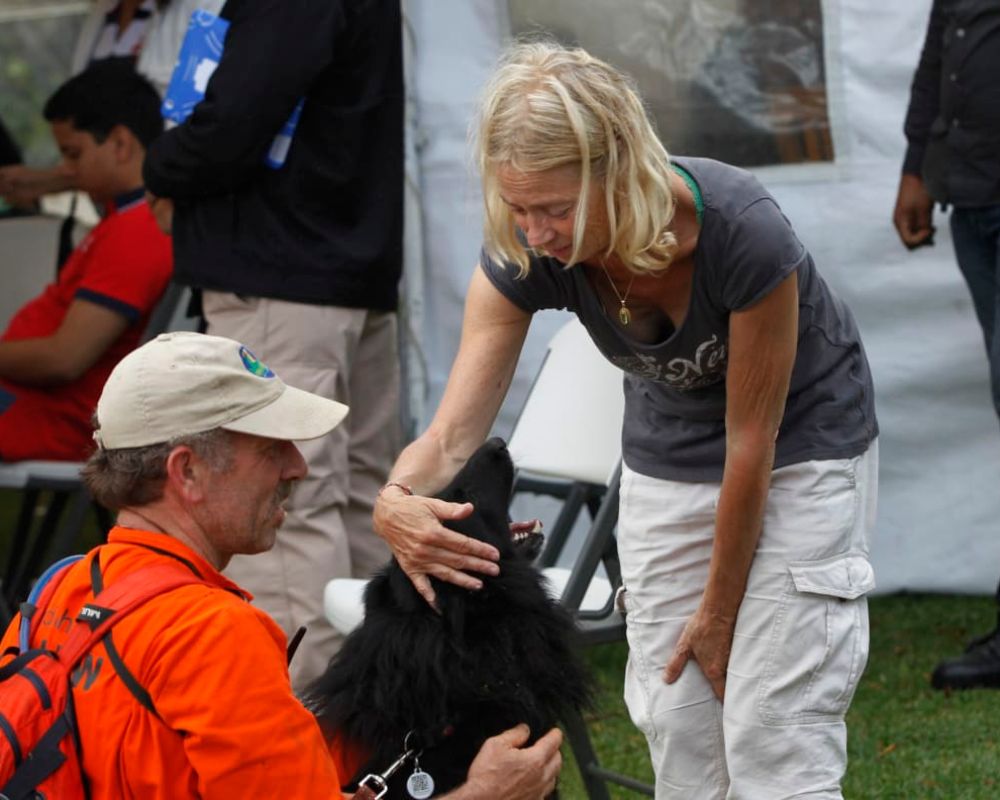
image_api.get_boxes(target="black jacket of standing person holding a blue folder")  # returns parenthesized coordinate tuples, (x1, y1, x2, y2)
(144, 0, 403, 311)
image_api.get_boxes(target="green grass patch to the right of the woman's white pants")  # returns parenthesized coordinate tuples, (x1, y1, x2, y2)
(844, 595, 1000, 800)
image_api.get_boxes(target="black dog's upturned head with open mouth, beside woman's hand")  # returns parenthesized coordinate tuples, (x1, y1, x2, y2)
(437, 437, 545, 561)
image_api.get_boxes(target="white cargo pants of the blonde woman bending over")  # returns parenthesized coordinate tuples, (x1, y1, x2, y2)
(618, 443, 878, 800)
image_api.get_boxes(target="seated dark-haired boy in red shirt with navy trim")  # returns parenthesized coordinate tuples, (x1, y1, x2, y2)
(0, 61, 172, 461)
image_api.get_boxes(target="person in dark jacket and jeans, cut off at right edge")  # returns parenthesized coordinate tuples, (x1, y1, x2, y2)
(893, 0, 1000, 689)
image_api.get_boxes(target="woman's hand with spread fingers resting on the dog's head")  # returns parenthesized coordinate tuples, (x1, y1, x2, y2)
(373, 486, 500, 607)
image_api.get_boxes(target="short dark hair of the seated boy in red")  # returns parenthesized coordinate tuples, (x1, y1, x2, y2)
(42, 58, 163, 148)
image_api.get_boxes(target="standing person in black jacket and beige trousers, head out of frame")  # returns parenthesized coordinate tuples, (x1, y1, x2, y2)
(145, 0, 403, 687)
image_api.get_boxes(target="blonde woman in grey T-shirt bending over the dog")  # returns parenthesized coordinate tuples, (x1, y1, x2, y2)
(375, 43, 877, 800)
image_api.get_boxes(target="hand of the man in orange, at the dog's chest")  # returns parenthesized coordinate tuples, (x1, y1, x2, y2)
(454, 725, 562, 800)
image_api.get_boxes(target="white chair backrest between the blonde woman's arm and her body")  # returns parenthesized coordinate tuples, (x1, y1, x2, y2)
(509, 317, 625, 484)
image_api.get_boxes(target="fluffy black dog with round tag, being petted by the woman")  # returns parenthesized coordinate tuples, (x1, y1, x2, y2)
(306, 439, 589, 800)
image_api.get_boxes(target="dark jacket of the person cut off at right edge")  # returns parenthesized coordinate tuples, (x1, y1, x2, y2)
(903, 0, 1000, 206)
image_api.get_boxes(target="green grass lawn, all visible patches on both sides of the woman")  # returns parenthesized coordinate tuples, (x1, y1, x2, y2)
(7, 491, 1000, 800)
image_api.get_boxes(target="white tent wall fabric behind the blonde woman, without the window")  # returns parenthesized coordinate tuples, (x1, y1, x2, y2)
(409, 0, 1000, 593)
